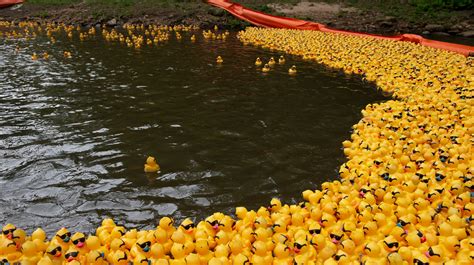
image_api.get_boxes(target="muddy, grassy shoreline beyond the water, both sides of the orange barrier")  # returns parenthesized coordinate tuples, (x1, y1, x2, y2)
(0, 3, 474, 37)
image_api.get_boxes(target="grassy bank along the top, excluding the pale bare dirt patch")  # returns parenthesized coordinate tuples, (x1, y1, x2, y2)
(0, 0, 474, 35)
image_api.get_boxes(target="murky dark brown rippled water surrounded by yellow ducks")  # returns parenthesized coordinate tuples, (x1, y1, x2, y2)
(0, 26, 383, 232)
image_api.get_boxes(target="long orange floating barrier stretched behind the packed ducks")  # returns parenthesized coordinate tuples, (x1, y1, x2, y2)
(207, 0, 474, 56)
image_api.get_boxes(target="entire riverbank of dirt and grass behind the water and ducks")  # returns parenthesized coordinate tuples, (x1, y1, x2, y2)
(0, 0, 474, 37)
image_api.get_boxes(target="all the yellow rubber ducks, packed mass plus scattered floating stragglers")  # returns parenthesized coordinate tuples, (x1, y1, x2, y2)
(0, 20, 474, 265)
